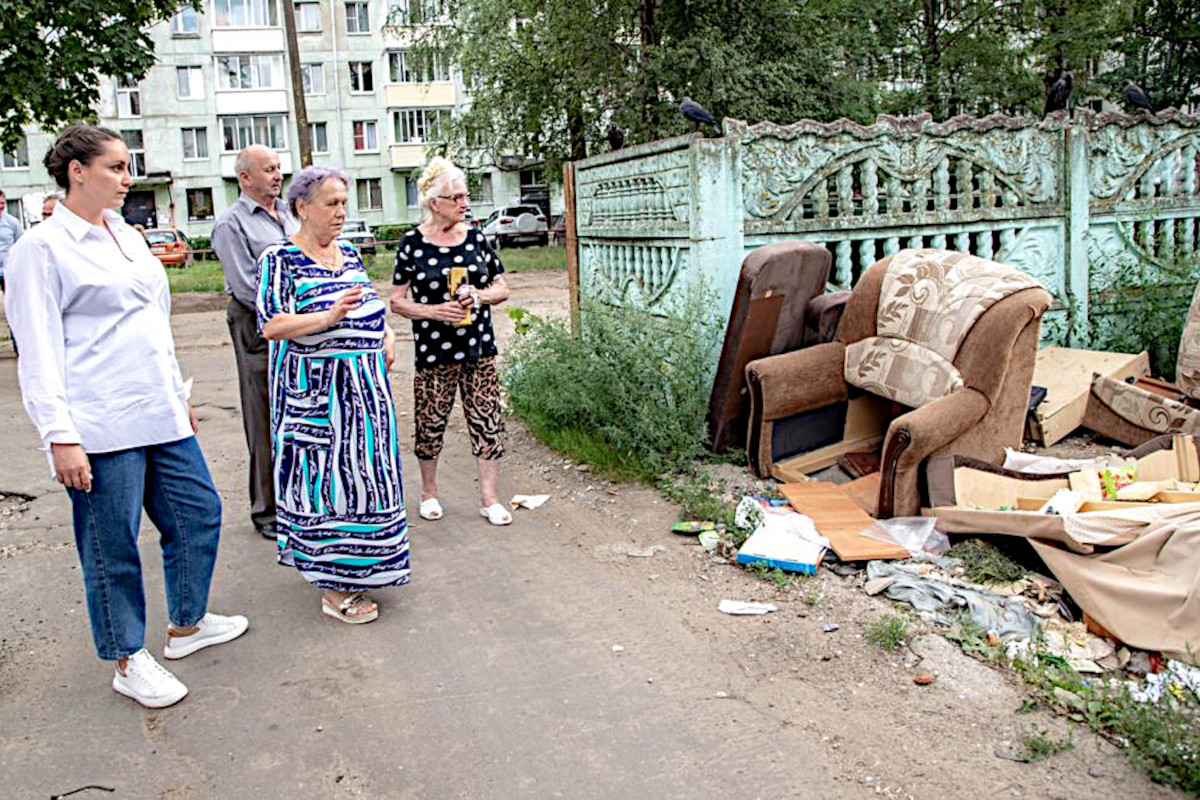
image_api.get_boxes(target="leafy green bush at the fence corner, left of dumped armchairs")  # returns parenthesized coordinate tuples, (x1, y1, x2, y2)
(504, 290, 715, 481)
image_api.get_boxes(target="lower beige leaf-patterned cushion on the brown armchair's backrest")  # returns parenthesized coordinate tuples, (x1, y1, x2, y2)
(845, 336, 962, 408)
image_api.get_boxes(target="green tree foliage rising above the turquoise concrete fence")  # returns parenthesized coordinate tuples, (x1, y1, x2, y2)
(416, 0, 1200, 172)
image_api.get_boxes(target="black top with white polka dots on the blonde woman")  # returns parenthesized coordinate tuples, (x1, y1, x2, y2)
(392, 228, 504, 369)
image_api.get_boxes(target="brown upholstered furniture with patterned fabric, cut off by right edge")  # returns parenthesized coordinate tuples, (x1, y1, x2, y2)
(1081, 280, 1200, 447)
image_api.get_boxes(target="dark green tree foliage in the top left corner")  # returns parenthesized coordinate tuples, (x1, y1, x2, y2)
(0, 0, 187, 150)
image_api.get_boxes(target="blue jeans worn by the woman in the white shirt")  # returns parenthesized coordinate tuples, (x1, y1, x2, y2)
(67, 437, 221, 661)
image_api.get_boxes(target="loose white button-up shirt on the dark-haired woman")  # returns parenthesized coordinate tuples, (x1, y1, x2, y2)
(4, 203, 192, 453)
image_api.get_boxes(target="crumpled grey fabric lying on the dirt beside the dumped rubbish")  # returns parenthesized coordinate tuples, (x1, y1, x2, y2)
(866, 561, 1039, 639)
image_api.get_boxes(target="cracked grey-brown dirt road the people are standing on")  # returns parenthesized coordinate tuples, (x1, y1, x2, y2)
(0, 273, 1171, 799)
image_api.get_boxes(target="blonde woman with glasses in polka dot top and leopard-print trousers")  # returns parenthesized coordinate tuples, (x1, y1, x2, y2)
(391, 158, 512, 525)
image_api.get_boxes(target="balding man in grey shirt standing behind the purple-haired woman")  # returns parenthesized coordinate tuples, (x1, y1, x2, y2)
(212, 144, 300, 540)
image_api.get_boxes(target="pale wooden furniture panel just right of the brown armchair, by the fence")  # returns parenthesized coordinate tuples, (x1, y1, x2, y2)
(1030, 347, 1150, 445)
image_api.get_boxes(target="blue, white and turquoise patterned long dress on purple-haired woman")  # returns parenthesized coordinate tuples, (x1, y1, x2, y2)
(258, 241, 409, 591)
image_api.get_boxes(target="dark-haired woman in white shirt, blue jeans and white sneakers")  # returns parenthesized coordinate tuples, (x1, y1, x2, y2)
(5, 125, 248, 708)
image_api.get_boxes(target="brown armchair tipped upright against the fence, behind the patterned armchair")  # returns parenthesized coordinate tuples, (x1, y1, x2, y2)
(708, 241, 850, 452)
